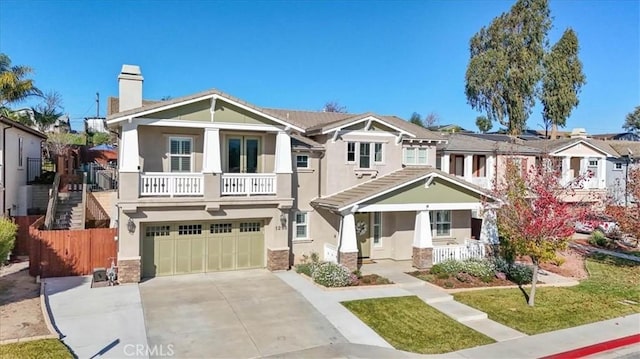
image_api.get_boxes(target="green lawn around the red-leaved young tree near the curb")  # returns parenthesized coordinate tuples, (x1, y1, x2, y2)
(454, 255, 640, 334)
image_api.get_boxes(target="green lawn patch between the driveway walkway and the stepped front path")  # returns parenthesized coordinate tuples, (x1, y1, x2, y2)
(342, 296, 494, 354)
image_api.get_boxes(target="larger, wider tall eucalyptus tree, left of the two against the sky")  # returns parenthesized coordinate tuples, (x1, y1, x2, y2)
(465, 0, 551, 135)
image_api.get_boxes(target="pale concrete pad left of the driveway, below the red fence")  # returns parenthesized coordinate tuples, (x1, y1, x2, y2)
(44, 276, 147, 358)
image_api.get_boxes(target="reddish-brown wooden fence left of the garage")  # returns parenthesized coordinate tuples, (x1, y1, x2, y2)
(29, 217, 118, 278)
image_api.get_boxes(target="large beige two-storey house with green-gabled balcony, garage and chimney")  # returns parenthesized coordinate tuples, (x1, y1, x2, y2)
(107, 65, 496, 282)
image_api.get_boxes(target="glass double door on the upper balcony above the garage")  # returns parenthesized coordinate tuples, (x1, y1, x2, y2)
(227, 136, 260, 173)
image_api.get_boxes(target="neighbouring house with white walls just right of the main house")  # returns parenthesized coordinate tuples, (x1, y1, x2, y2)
(436, 134, 541, 190)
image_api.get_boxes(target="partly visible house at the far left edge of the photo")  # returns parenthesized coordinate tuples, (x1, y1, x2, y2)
(0, 116, 47, 216)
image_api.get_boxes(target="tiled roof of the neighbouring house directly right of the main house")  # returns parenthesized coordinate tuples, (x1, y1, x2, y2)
(438, 134, 542, 155)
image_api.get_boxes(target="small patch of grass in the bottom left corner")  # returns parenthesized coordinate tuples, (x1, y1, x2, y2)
(0, 339, 73, 359)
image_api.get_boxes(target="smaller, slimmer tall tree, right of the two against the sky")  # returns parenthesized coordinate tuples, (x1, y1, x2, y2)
(540, 28, 586, 139)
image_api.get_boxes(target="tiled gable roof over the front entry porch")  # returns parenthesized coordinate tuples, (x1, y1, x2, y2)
(311, 166, 490, 211)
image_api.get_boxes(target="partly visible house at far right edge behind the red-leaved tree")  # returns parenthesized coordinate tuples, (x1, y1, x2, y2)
(607, 140, 640, 205)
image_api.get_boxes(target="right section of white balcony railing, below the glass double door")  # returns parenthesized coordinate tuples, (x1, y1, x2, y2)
(222, 173, 277, 196)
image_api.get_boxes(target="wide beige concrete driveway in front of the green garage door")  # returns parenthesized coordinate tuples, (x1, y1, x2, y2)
(140, 270, 346, 358)
